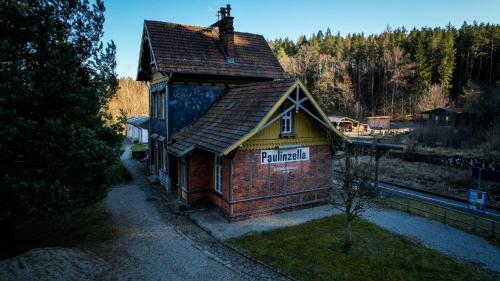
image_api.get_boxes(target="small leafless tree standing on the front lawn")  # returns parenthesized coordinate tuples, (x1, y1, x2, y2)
(332, 147, 378, 250)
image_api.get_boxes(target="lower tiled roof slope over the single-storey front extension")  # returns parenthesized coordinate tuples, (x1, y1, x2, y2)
(168, 79, 296, 155)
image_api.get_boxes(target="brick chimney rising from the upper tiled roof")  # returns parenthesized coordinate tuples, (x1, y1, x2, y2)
(212, 4, 234, 63)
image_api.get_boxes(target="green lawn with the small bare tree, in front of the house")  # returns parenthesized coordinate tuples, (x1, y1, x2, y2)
(229, 215, 499, 281)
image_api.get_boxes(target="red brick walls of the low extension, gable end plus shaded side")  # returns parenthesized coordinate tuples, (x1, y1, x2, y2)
(183, 145, 331, 220)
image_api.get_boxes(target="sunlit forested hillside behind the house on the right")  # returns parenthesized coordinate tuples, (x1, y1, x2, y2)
(269, 22, 500, 132)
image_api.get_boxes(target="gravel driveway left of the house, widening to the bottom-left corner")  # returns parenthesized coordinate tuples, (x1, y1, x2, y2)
(0, 145, 289, 281)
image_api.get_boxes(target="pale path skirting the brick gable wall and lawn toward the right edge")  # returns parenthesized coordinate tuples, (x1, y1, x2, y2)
(191, 203, 500, 272)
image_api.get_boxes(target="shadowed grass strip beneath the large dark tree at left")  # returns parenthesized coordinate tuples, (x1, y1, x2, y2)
(0, 202, 115, 259)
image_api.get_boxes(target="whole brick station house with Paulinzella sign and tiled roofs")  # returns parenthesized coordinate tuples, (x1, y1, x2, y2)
(137, 5, 344, 220)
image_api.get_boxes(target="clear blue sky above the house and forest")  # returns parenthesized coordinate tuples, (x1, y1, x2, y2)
(103, 0, 500, 78)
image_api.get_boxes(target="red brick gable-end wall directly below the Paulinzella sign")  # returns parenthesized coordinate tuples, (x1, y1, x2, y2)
(230, 145, 331, 217)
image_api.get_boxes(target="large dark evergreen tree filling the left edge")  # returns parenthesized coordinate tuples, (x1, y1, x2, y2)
(0, 0, 121, 243)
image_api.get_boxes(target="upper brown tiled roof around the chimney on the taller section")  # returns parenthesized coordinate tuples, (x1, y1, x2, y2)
(144, 21, 288, 79)
